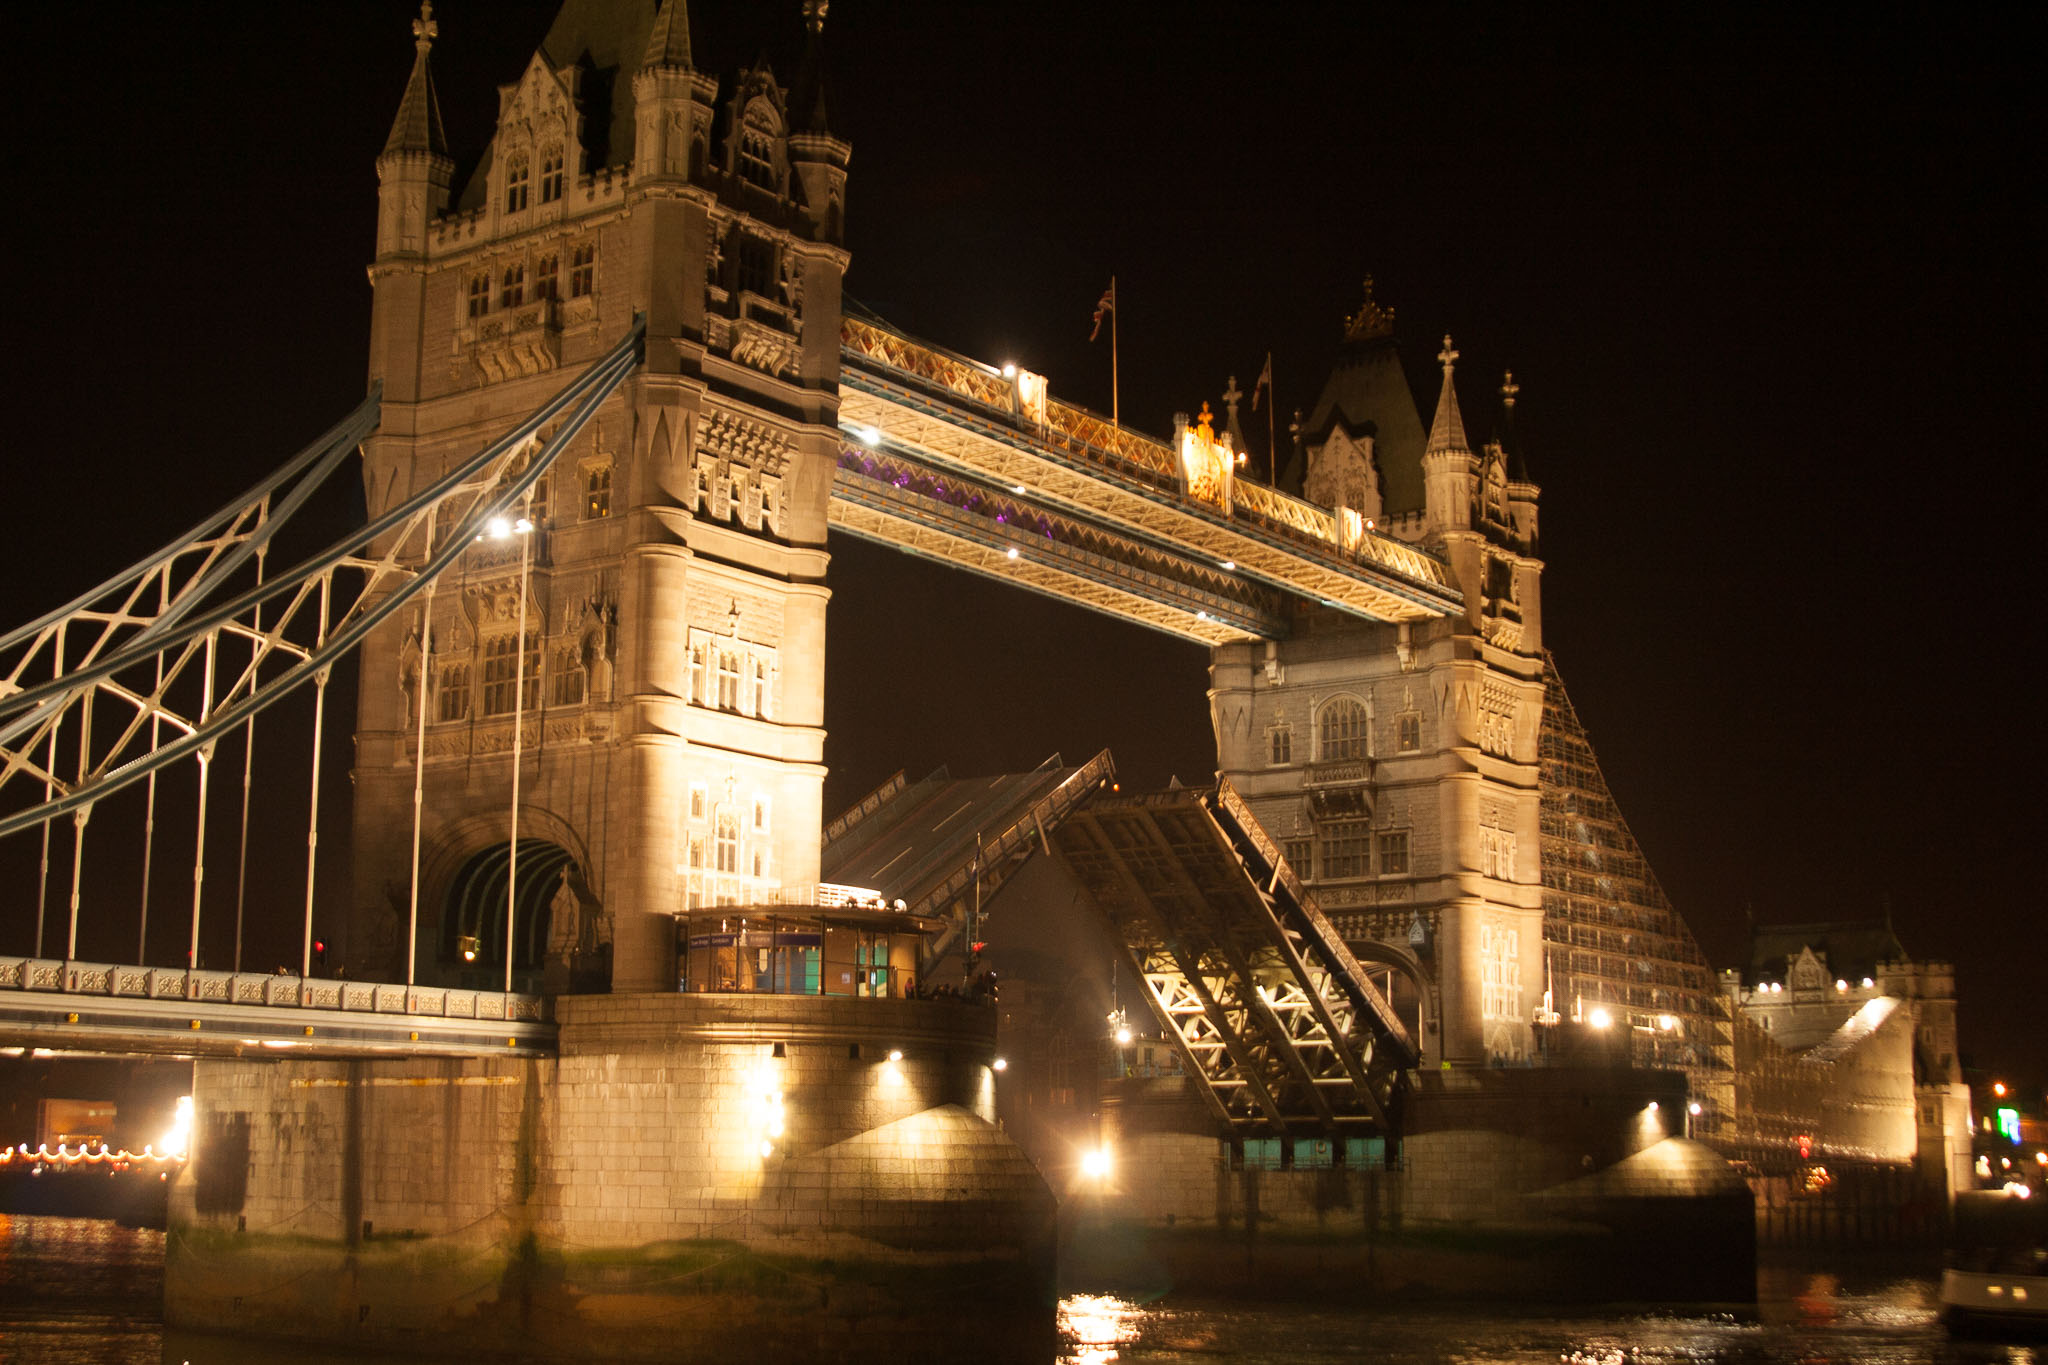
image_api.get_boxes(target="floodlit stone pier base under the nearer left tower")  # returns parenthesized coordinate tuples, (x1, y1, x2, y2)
(166, 995, 1053, 1361)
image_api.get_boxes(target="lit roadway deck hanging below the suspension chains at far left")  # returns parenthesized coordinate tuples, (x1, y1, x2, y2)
(0, 958, 555, 1058)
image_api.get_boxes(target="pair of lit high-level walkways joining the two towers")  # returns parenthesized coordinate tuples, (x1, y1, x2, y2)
(827, 317, 1462, 645)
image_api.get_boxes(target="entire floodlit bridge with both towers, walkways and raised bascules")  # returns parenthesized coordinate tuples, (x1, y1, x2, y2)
(0, 0, 1966, 1359)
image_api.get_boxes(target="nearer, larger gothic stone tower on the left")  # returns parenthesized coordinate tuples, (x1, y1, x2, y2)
(348, 0, 850, 990)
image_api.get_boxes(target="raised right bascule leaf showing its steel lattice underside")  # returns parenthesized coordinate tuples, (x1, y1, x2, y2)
(1057, 788, 1415, 1132)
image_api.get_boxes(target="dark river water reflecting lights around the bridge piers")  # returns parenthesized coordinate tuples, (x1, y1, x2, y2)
(0, 1216, 2048, 1365)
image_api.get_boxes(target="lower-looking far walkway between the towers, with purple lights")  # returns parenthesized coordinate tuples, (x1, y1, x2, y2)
(827, 446, 1286, 645)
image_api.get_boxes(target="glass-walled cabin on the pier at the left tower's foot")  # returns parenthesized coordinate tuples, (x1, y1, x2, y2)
(676, 896, 944, 999)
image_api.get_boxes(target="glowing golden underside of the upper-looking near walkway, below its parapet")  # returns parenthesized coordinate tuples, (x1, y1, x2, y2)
(840, 364, 1460, 620)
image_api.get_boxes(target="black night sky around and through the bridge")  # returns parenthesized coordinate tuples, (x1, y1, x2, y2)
(0, 0, 2048, 1083)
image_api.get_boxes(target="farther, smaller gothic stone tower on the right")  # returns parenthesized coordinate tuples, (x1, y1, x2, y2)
(1210, 280, 1544, 1062)
